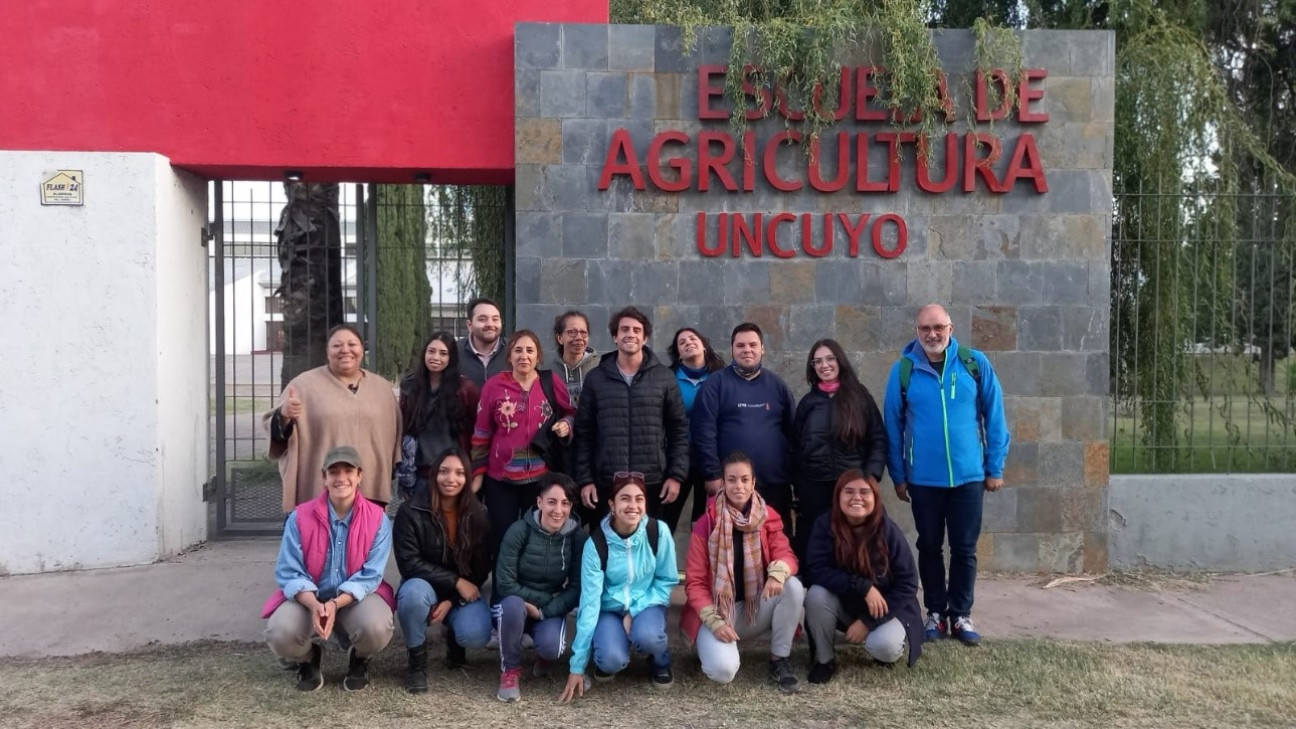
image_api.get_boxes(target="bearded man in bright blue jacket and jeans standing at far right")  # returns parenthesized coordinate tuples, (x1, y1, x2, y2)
(885, 304, 1008, 646)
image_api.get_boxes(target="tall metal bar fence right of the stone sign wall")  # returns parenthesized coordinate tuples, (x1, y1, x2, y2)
(1111, 180, 1296, 473)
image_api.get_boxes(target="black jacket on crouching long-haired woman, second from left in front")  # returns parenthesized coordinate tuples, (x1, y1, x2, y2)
(391, 486, 494, 601)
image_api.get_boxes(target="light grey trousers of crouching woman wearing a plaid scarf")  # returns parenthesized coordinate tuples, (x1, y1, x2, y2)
(697, 577, 806, 684)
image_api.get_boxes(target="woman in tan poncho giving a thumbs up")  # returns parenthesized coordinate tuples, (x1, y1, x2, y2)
(262, 324, 400, 514)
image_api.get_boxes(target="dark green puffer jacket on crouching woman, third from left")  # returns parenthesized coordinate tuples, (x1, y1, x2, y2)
(495, 506, 586, 617)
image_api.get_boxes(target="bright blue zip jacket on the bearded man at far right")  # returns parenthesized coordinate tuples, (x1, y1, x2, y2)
(885, 337, 1008, 486)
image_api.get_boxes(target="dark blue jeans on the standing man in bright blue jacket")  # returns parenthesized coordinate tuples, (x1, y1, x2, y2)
(908, 481, 985, 620)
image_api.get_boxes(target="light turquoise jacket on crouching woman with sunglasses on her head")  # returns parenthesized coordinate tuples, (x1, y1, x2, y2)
(569, 515, 679, 673)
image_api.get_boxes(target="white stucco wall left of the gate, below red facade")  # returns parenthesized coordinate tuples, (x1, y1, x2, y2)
(0, 152, 207, 573)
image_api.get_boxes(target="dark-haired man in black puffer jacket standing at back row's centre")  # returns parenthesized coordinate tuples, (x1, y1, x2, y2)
(572, 306, 688, 524)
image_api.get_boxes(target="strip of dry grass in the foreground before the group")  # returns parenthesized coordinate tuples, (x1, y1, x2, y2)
(0, 638, 1296, 729)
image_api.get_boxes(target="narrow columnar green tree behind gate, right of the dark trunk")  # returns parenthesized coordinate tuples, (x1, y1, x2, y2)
(371, 184, 432, 380)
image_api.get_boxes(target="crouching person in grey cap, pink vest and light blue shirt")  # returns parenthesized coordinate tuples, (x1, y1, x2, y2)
(262, 446, 395, 691)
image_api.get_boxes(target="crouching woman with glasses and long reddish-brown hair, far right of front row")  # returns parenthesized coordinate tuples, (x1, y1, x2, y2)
(806, 470, 925, 684)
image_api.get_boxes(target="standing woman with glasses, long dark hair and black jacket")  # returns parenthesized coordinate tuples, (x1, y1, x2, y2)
(794, 339, 886, 560)
